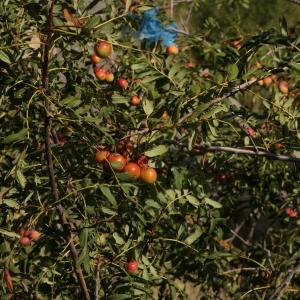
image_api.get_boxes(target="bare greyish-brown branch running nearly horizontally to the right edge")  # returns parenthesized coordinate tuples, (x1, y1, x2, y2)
(164, 140, 300, 163)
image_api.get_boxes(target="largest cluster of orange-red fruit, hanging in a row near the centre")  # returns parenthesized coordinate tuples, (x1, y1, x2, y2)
(95, 147, 157, 184)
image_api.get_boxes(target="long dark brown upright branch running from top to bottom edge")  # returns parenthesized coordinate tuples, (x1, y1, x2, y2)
(42, 0, 90, 300)
